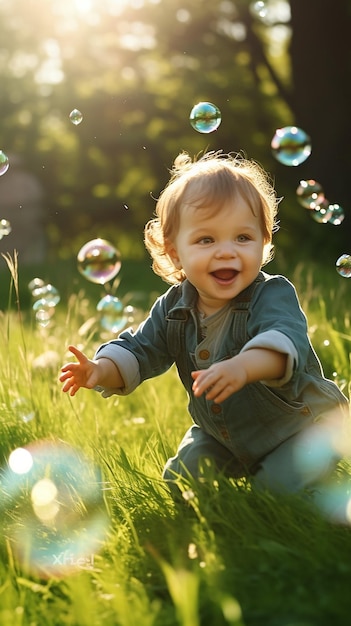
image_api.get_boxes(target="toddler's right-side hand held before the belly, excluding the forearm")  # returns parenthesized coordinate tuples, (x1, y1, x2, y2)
(191, 359, 247, 403)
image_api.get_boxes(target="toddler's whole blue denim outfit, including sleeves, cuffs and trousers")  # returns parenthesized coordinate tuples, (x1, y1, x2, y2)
(96, 272, 350, 491)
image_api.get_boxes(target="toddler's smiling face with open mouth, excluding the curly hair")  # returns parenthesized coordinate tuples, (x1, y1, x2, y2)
(167, 195, 265, 315)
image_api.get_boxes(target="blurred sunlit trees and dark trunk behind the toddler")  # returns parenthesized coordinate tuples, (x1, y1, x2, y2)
(0, 0, 351, 276)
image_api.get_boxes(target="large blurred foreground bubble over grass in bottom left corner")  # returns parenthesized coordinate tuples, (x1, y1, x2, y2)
(0, 441, 107, 577)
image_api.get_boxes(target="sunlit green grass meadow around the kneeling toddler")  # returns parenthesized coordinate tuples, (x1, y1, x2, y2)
(0, 251, 351, 626)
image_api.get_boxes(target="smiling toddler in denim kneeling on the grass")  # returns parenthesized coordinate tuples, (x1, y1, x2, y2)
(60, 152, 349, 492)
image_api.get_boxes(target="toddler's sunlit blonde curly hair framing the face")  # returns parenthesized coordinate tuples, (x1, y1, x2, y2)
(144, 151, 279, 284)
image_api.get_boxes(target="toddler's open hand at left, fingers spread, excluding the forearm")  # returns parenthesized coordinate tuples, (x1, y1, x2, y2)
(59, 346, 98, 396)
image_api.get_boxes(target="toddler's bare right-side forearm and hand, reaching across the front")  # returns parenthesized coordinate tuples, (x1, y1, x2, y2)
(191, 348, 287, 403)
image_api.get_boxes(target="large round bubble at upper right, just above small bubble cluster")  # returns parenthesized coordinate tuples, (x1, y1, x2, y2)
(271, 126, 312, 166)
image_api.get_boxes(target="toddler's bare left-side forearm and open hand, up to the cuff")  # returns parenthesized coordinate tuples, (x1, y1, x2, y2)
(59, 346, 124, 396)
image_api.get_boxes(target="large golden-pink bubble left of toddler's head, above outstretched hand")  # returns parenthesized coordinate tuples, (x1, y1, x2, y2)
(77, 239, 121, 285)
